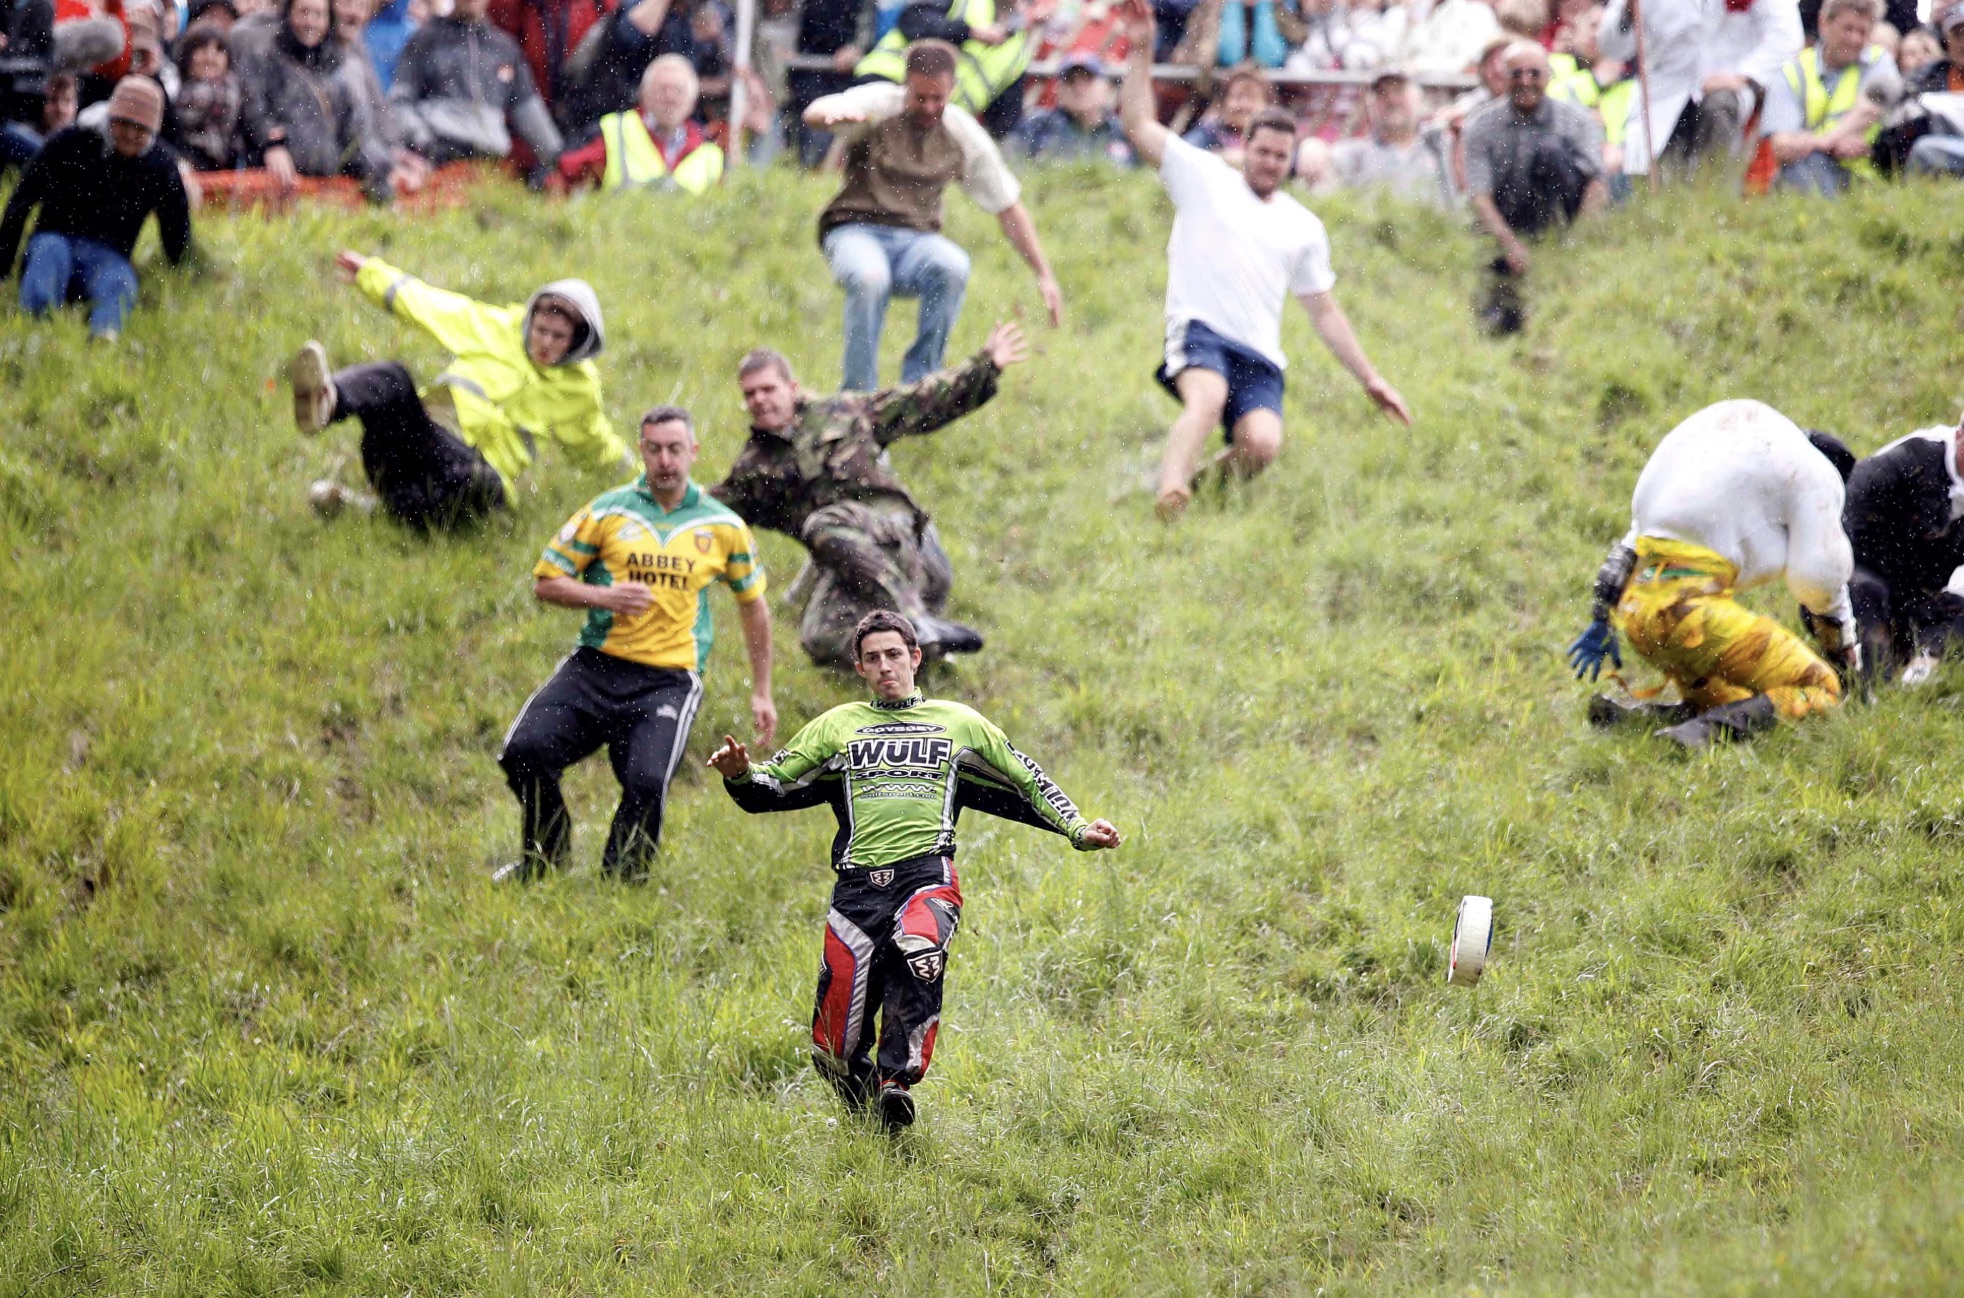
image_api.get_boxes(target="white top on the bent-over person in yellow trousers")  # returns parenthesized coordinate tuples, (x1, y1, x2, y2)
(1624, 401, 1854, 626)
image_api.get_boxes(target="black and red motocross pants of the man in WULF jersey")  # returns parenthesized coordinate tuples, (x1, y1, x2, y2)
(811, 856, 962, 1104)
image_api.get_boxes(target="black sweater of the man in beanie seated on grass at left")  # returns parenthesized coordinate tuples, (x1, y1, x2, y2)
(0, 126, 191, 279)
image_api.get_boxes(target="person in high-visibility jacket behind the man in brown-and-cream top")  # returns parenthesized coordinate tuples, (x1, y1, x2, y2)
(852, 0, 1053, 139)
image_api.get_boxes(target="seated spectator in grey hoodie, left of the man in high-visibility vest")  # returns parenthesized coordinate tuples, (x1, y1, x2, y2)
(389, 0, 562, 177)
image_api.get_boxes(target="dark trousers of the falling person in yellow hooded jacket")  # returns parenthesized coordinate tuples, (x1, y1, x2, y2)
(332, 361, 505, 528)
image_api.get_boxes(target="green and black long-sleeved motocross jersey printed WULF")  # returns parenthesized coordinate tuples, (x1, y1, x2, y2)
(723, 693, 1090, 870)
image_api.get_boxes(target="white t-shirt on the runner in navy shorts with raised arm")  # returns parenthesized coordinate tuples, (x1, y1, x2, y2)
(1159, 135, 1337, 369)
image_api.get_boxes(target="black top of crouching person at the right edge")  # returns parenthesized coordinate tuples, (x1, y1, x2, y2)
(1842, 428, 1964, 593)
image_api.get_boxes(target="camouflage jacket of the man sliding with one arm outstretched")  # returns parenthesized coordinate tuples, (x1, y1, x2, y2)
(709, 352, 1002, 546)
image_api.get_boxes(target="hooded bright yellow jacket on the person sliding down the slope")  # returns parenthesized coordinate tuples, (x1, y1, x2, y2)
(355, 257, 627, 495)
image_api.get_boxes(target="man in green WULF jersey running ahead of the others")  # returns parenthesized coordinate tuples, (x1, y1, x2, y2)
(709, 609, 1119, 1129)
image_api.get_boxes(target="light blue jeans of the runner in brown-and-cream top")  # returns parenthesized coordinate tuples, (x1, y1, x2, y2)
(825, 224, 968, 393)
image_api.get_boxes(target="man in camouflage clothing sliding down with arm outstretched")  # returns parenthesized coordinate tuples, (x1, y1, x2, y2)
(709, 324, 1027, 668)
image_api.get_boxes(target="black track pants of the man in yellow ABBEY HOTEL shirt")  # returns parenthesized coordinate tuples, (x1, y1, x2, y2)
(497, 648, 703, 876)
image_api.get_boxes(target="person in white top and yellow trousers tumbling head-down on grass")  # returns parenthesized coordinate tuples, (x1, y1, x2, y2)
(1569, 401, 1860, 748)
